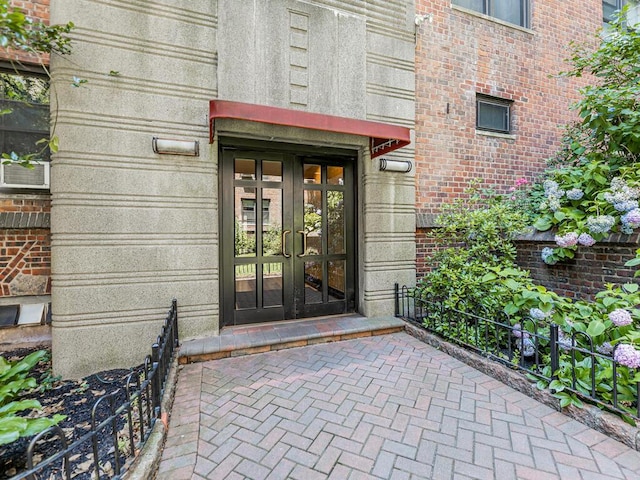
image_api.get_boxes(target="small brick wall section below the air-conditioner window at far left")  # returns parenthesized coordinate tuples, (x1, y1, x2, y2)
(0, 195, 51, 297)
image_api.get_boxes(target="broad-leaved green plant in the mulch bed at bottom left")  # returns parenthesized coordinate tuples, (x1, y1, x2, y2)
(0, 350, 65, 445)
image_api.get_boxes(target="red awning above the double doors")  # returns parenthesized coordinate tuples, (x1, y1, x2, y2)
(209, 100, 411, 157)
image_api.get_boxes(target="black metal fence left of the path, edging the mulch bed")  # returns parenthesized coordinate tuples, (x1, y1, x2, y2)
(11, 299, 179, 480)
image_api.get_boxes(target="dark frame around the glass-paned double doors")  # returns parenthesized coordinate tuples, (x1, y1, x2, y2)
(218, 137, 359, 328)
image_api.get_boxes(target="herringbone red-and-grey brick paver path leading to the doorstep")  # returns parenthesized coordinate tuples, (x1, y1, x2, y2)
(158, 333, 640, 480)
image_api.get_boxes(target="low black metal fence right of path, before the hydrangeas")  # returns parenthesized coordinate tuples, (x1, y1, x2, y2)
(395, 284, 640, 420)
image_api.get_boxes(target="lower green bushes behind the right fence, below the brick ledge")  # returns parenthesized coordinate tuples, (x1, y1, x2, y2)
(417, 172, 640, 414)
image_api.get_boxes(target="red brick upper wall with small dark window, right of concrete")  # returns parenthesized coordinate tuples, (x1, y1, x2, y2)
(416, 0, 602, 218)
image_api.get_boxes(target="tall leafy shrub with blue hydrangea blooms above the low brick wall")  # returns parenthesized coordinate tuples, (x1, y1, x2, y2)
(534, 6, 640, 264)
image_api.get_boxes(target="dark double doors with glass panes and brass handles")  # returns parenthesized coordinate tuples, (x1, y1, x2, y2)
(221, 149, 355, 325)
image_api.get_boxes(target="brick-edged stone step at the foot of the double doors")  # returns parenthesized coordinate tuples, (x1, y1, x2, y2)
(178, 314, 405, 365)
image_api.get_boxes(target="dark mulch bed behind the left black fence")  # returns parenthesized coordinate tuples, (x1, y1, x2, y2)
(0, 346, 141, 480)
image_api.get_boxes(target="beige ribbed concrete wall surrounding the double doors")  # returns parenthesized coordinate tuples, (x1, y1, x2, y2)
(51, 0, 415, 376)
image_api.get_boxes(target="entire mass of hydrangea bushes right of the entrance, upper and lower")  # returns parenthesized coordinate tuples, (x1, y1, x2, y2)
(419, 10, 640, 412)
